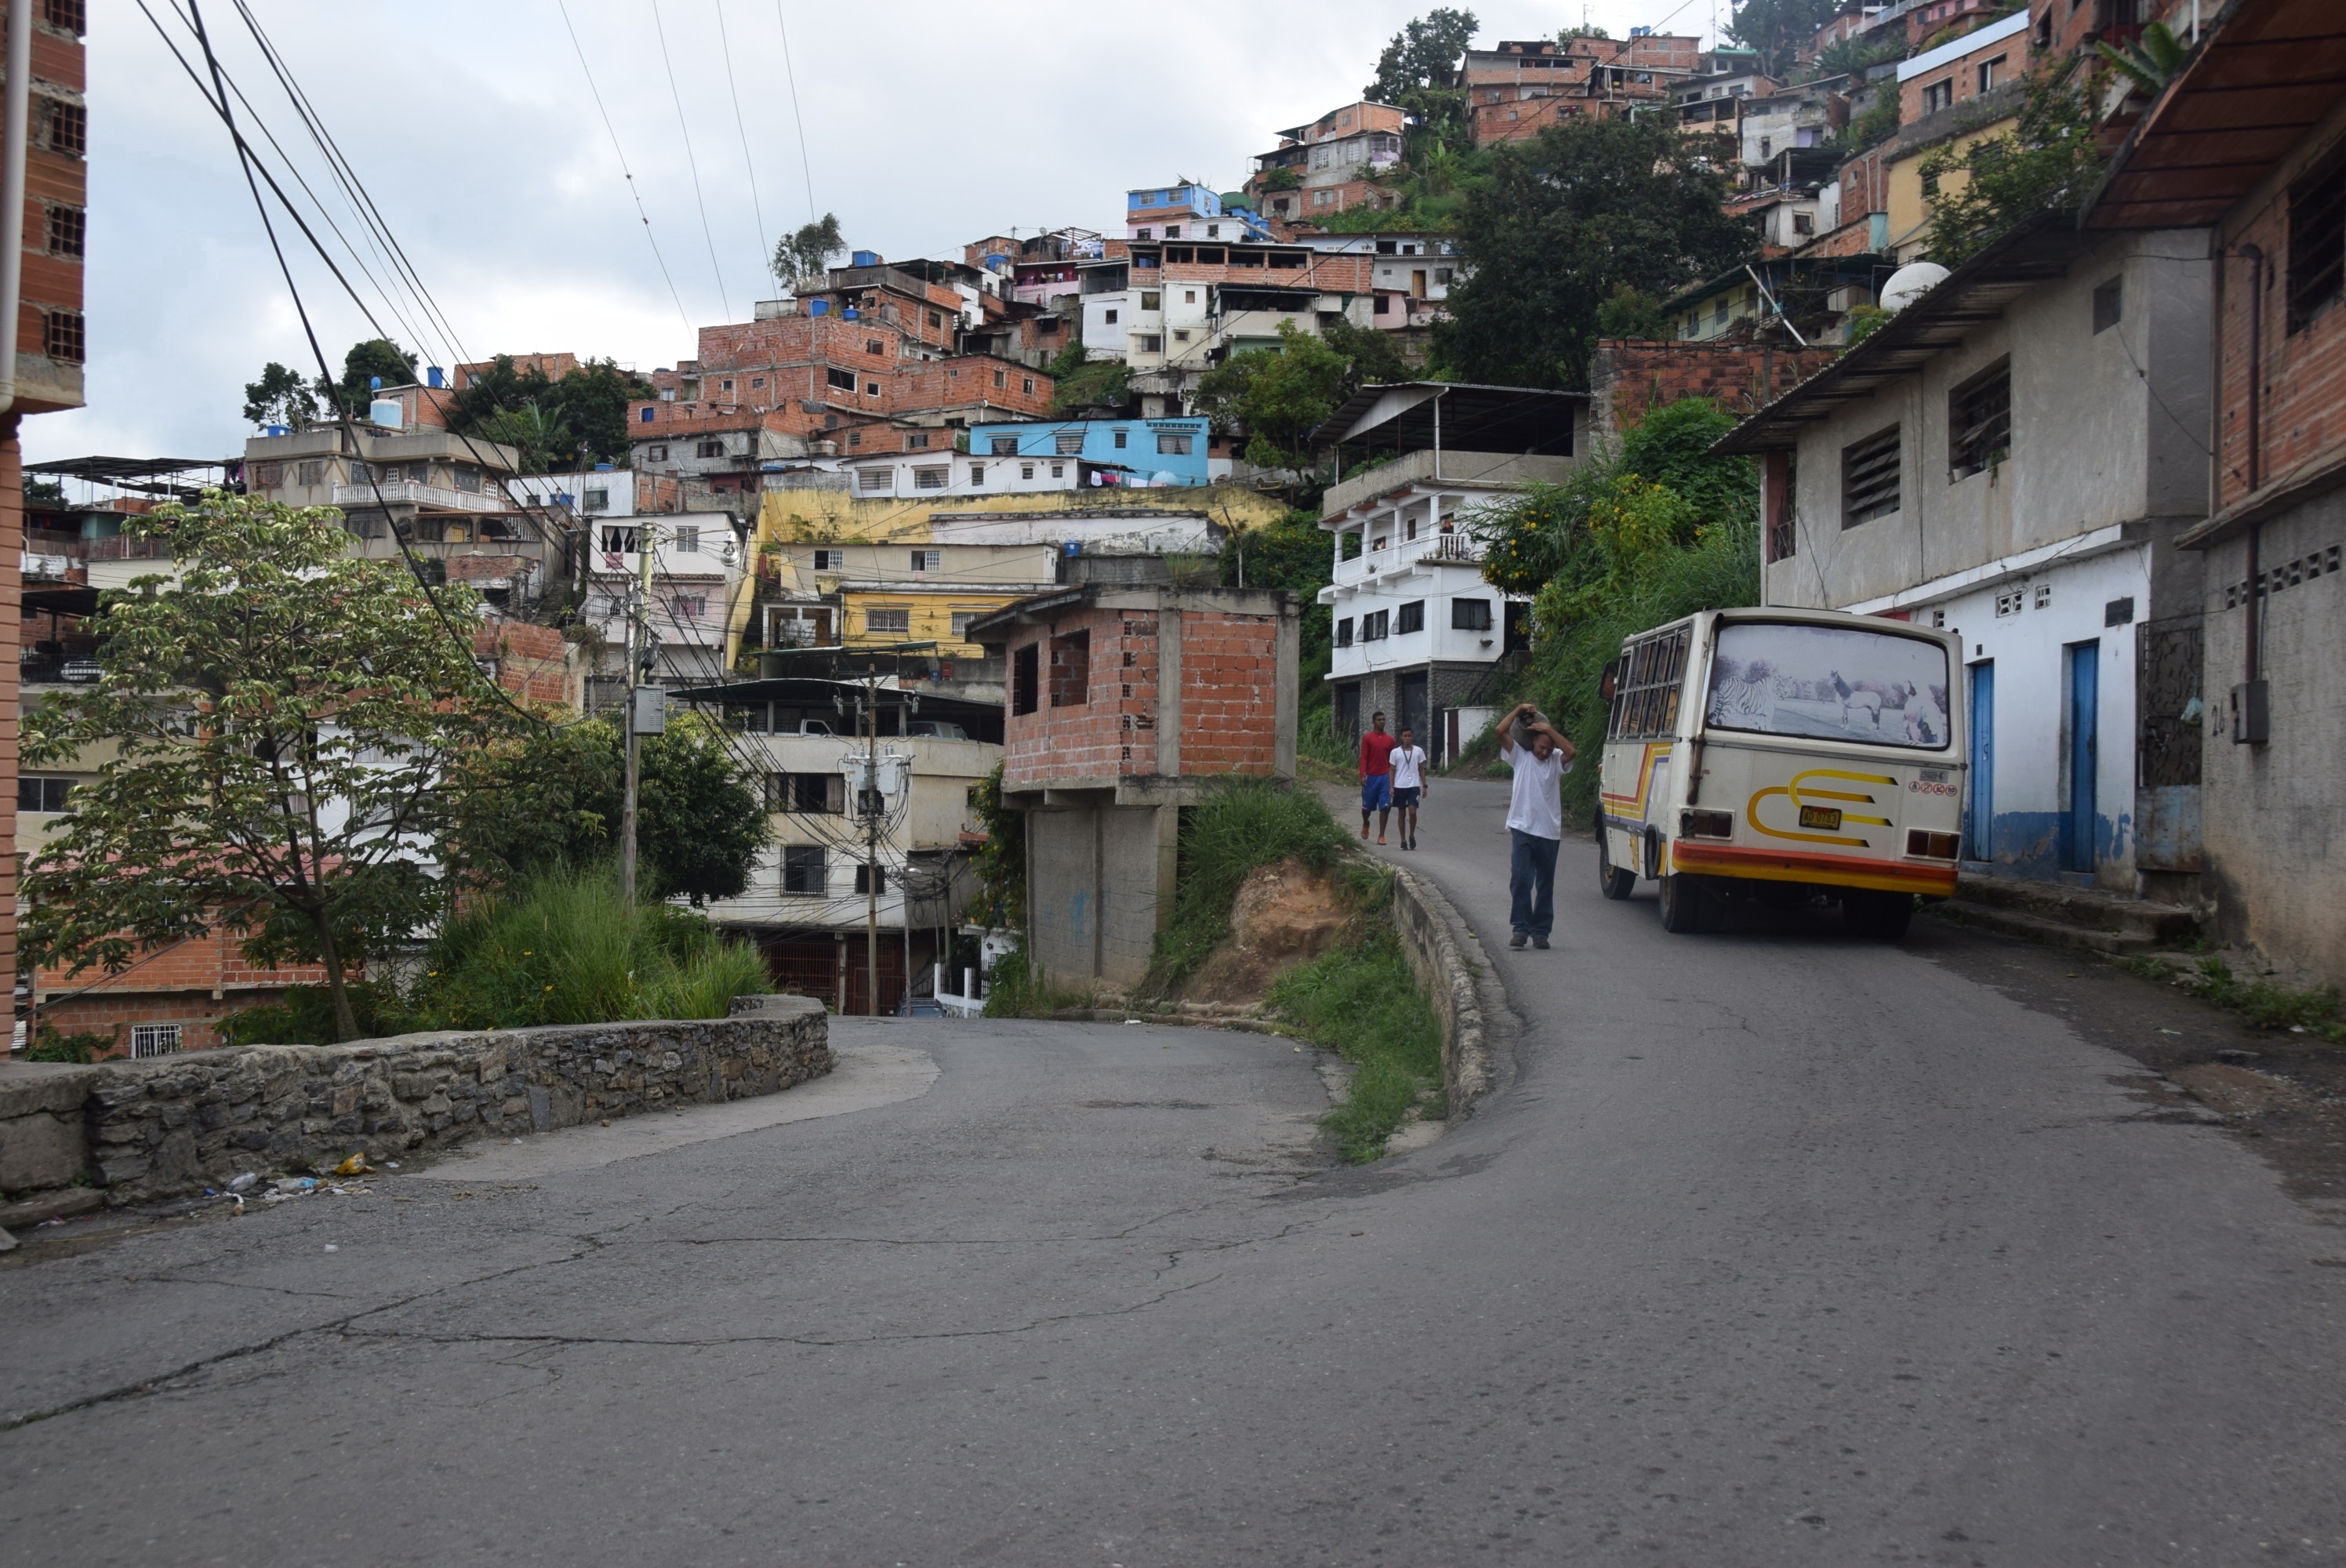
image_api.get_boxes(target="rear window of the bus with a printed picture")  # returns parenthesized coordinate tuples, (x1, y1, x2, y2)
(1703, 619, 1949, 751)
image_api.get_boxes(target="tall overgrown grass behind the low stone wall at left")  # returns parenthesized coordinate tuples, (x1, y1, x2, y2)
(223, 866, 774, 1044)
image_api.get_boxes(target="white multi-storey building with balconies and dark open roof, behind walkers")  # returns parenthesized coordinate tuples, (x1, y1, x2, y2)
(1316, 383, 1589, 758)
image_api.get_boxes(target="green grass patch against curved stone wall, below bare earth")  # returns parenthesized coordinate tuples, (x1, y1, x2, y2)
(1267, 930, 1443, 1164)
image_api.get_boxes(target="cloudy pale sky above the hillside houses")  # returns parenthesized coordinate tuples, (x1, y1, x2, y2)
(24, 0, 1712, 463)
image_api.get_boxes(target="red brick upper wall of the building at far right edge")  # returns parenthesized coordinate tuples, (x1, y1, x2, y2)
(2217, 195, 2346, 507)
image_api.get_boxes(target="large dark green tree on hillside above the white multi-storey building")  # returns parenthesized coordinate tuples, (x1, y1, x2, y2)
(1433, 120, 1750, 387)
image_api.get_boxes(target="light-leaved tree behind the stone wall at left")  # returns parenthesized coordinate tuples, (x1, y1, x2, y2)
(24, 491, 518, 1040)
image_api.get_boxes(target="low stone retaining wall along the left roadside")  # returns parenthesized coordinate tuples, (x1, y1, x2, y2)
(0, 995, 833, 1202)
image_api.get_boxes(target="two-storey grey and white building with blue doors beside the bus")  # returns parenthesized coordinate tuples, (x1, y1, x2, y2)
(1724, 223, 2210, 897)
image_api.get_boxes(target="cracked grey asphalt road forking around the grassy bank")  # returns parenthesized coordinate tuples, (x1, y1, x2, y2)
(0, 782, 2346, 1568)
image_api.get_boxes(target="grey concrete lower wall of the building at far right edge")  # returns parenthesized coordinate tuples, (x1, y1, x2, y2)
(2200, 491, 2346, 985)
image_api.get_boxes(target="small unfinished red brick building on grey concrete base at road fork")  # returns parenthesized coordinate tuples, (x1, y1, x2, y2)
(969, 585, 1302, 985)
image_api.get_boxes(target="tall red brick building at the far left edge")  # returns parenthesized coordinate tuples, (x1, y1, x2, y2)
(0, 0, 89, 1018)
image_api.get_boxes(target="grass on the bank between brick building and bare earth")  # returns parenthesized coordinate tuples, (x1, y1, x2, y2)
(1142, 775, 1344, 995)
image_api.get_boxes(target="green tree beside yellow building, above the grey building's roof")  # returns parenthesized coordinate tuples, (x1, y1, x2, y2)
(1916, 73, 2104, 267)
